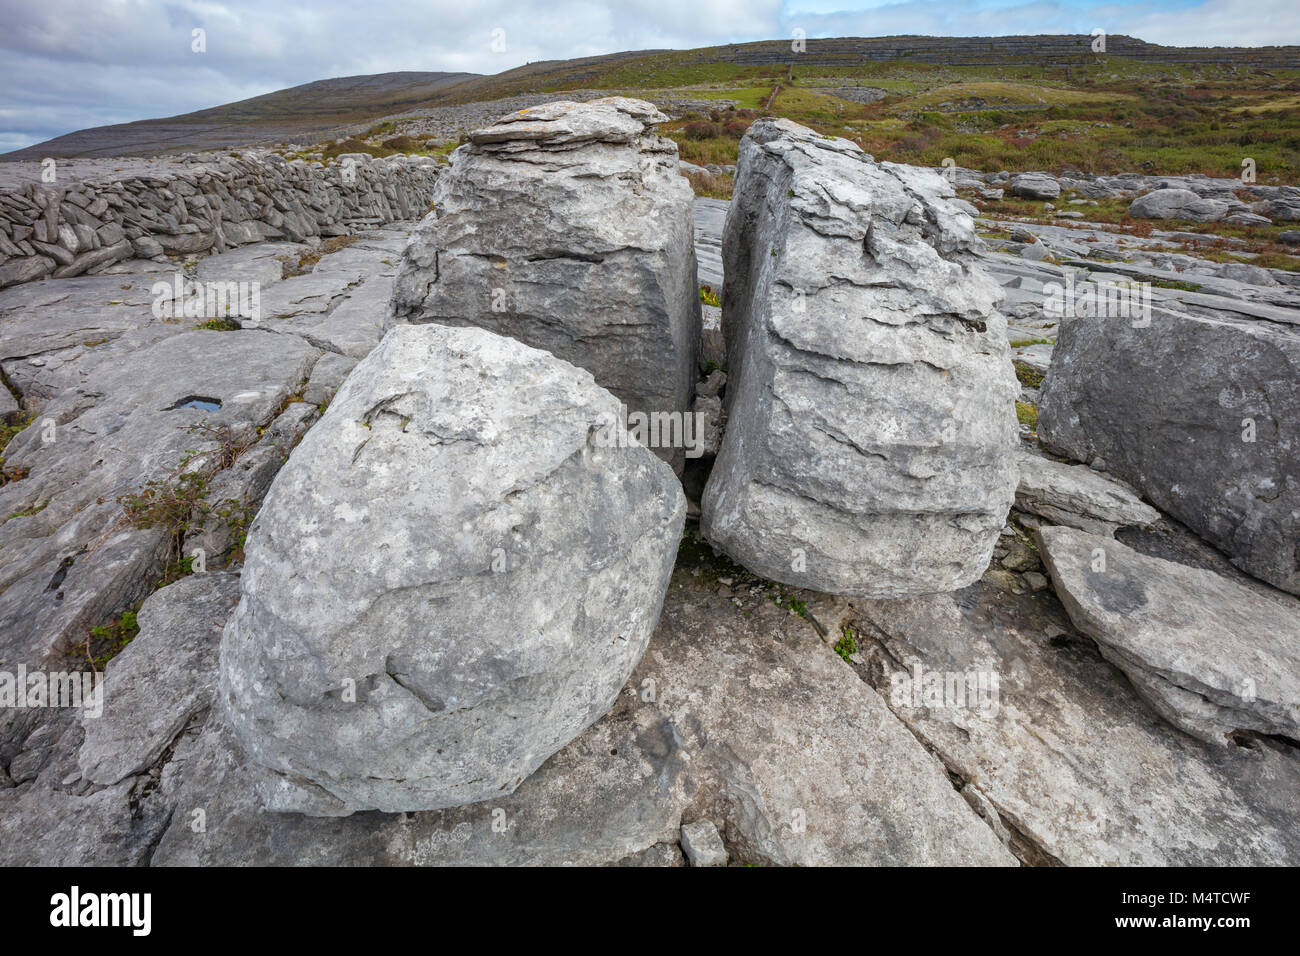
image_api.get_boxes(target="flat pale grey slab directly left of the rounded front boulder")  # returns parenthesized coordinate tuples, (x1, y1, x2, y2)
(78, 571, 239, 786)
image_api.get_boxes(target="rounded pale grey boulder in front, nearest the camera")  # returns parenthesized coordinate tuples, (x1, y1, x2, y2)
(220, 325, 685, 816)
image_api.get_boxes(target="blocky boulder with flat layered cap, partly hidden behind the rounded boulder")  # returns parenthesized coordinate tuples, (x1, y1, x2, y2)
(389, 96, 699, 464)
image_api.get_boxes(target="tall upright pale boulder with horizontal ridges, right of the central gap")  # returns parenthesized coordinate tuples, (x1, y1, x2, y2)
(702, 120, 1018, 597)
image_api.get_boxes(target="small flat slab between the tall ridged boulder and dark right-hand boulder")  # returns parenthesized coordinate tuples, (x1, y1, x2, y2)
(1015, 451, 1160, 537)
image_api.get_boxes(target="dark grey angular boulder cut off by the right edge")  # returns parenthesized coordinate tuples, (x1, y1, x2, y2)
(1039, 308, 1300, 593)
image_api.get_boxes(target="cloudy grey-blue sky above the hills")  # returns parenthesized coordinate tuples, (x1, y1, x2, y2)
(0, 0, 1300, 152)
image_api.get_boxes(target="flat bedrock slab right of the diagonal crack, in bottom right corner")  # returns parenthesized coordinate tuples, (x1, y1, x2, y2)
(855, 580, 1300, 866)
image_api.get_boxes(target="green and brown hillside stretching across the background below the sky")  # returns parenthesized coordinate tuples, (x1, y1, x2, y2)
(10, 35, 1300, 161)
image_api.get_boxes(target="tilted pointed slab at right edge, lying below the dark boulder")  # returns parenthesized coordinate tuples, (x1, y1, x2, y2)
(1037, 527, 1300, 747)
